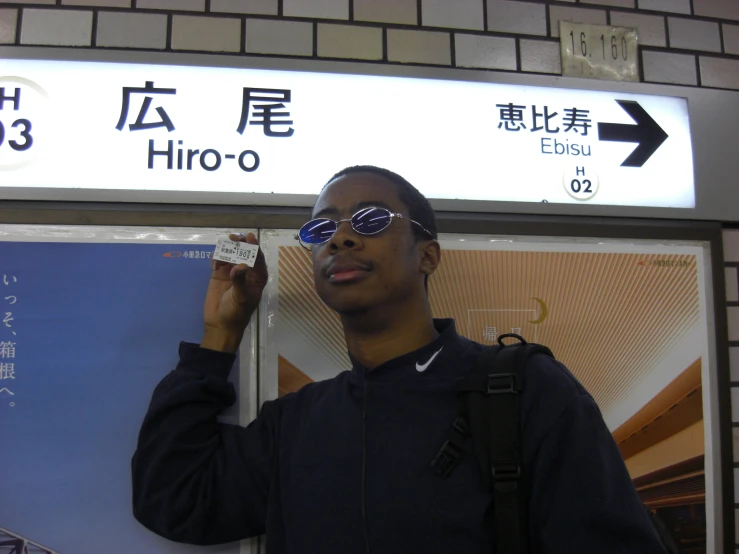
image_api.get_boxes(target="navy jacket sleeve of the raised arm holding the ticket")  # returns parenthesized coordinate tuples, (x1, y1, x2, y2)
(131, 343, 280, 544)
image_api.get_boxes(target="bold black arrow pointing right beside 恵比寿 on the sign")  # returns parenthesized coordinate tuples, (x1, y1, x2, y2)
(598, 100, 667, 167)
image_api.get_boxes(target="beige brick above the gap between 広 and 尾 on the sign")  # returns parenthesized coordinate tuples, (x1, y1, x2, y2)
(172, 15, 241, 52)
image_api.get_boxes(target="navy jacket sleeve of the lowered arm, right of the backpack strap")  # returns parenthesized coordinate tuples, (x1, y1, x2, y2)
(529, 393, 666, 554)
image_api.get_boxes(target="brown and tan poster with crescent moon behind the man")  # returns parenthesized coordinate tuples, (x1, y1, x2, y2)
(260, 226, 718, 553)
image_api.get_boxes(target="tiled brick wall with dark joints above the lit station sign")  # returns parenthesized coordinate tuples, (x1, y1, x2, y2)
(0, 0, 739, 90)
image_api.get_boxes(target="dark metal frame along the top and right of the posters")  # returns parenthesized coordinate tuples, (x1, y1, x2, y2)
(0, 201, 735, 554)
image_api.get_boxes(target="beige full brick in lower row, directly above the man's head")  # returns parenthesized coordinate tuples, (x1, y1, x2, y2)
(318, 23, 382, 60)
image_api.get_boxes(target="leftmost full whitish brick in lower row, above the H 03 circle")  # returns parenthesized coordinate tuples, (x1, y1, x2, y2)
(21, 9, 92, 46)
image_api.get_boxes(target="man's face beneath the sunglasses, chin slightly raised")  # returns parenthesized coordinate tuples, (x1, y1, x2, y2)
(313, 173, 425, 313)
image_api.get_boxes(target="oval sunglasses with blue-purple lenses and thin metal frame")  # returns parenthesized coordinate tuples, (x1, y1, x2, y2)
(295, 207, 433, 250)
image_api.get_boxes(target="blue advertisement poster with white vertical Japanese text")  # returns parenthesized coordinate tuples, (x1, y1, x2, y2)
(0, 225, 255, 554)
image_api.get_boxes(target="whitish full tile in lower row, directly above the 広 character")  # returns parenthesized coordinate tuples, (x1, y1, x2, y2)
(96, 12, 167, 49)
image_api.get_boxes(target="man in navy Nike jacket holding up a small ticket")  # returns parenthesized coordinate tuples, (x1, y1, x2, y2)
(132, 167, 664, 554)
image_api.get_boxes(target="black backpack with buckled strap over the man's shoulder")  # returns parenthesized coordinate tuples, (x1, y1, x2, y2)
(431, 334, 679, 554)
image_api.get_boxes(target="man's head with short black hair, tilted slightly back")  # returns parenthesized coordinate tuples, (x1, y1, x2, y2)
(304, 166, 441, 314)
